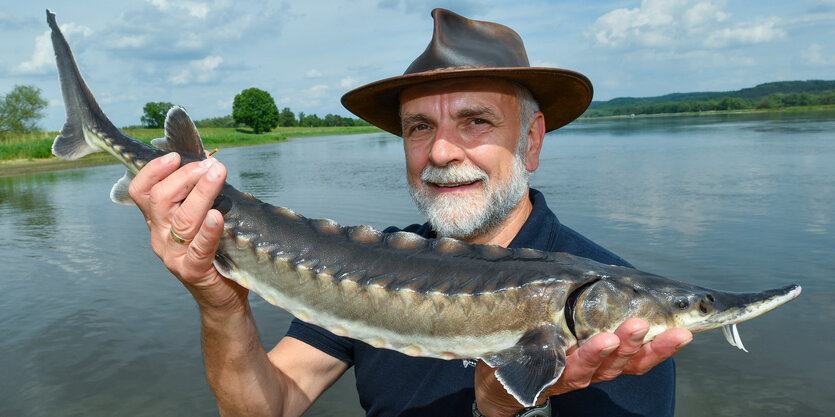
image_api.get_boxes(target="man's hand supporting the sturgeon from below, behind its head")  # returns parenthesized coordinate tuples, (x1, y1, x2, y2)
(475, 319, 693, 417)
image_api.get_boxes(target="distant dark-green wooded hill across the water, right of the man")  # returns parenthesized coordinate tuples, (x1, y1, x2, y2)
(584, 80, 835, 117)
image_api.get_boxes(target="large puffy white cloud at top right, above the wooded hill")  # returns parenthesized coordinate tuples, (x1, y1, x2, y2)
(586, 0, 786, 49)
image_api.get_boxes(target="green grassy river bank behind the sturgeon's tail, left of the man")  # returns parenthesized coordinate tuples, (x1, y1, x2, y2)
(0, 126, 381, 177)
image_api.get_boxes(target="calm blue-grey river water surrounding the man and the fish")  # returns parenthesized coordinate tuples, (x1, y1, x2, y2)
(0, 111, 835, 417)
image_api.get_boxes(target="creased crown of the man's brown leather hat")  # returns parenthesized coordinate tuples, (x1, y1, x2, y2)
(404, 9, 530, 75)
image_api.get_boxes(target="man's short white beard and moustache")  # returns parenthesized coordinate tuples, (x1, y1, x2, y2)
(409, 152, 530, 240)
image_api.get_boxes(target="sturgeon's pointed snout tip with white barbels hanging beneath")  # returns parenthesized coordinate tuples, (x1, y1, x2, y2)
(687, 284, 802, 352)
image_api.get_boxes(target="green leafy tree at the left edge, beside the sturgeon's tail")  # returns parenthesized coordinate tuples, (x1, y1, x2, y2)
(0, 85, 49, 133)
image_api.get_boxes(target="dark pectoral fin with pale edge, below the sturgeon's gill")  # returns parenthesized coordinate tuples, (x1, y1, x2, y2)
(481, 324, 566, 407)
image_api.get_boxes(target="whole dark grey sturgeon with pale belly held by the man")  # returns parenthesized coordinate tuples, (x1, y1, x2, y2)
(47, 10, 801, 406)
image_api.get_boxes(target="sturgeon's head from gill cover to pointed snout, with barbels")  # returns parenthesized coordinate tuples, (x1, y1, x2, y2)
(565, 271, 801, 349)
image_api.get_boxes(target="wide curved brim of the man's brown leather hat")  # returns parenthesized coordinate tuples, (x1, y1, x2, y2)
(342, 67, 594, 136)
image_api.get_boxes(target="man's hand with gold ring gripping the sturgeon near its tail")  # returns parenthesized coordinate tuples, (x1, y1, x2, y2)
(125, 152, 247, 312)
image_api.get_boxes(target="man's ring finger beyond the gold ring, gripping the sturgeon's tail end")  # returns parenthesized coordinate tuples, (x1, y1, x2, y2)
(171, 159, 226, 240)
